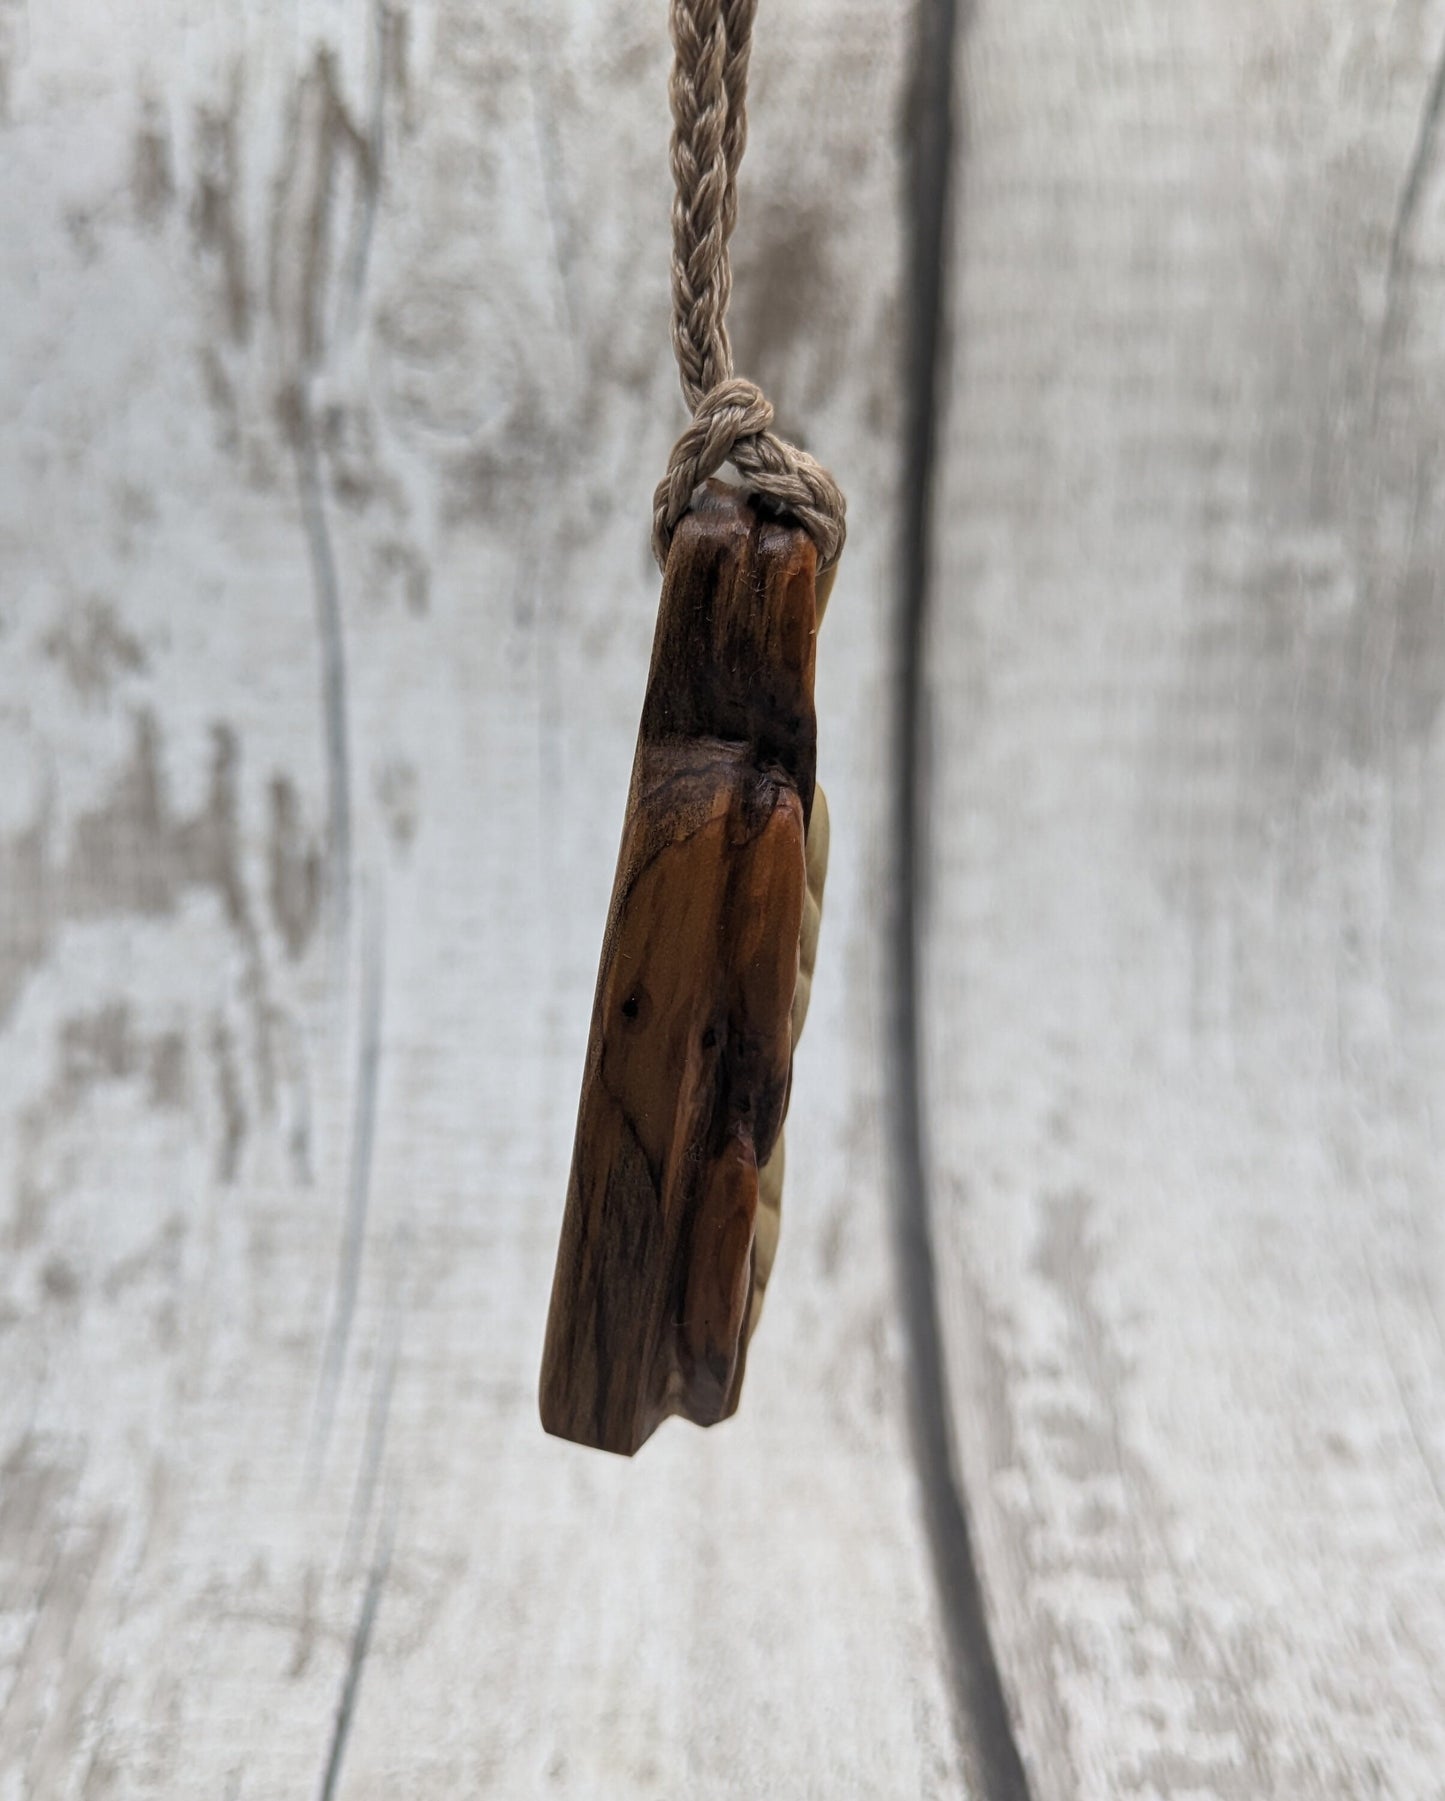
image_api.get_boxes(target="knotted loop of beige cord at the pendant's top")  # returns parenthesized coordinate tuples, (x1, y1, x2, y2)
(652, 375, 847, 569)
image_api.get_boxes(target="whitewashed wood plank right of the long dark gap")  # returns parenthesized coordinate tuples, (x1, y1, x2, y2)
(924, 0, 1445, 1801)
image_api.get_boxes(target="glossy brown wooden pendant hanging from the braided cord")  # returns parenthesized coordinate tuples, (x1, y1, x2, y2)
(541, 483, 831, 1455)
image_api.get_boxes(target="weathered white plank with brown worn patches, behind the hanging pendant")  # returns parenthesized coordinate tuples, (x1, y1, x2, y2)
(0, 0, 957, 1801)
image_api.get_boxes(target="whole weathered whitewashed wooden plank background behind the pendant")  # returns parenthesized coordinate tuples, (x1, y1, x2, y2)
(0, 0, 1445, 1801)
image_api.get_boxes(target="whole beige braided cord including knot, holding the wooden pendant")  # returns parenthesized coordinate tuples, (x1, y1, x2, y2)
(652, 0, 845, 569)
